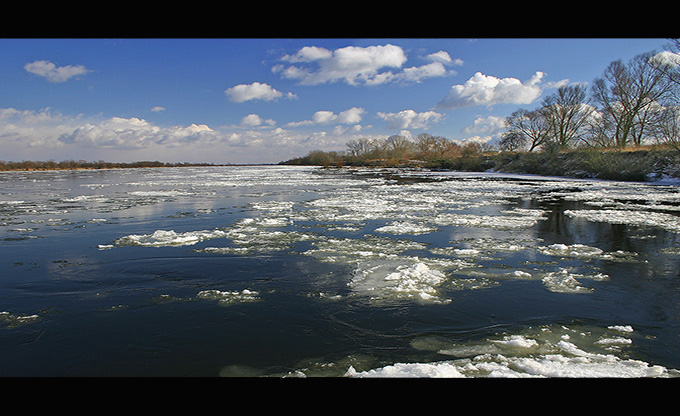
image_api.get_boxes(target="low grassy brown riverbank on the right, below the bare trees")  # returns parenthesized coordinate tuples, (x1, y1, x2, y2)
(282, 147, 680, 182)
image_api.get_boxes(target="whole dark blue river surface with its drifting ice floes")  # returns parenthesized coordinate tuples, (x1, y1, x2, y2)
(0, 166, 680, 377)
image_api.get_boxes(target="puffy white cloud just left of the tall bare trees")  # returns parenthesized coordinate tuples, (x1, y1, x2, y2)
(435, 71, 545, 109)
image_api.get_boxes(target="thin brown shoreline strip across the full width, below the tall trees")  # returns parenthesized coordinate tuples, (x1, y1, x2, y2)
(5, 148, 680, 182)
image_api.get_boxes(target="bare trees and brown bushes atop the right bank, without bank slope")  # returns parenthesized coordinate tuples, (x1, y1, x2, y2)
(283, 39, 680, 165)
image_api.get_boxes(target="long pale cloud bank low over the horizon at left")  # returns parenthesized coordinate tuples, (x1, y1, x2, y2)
(0, 108, 363, 163)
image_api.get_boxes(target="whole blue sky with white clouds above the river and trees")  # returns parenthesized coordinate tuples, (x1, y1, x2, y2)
(0, 38, 667, 163)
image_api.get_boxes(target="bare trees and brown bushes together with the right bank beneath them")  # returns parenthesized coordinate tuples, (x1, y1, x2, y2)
(281, 39, 680, 180)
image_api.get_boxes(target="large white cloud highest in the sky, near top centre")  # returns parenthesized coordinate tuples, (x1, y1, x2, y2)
(272, 44, 453, 85)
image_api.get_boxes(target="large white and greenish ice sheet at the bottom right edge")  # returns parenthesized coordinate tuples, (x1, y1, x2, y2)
(345, 325, 680, 378)
